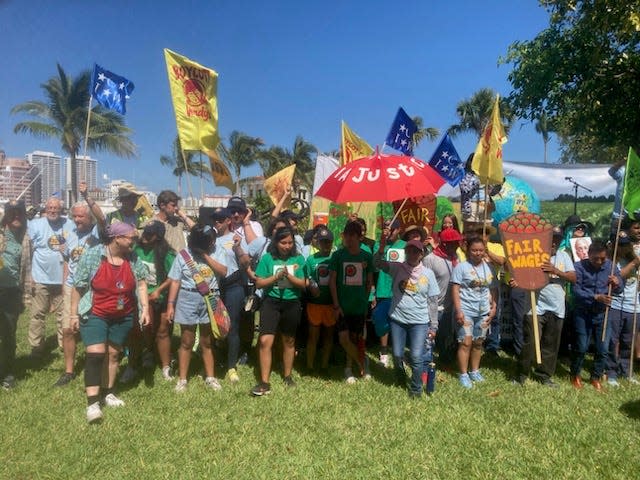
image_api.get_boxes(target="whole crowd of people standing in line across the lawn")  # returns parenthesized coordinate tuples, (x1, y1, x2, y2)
(0, 185, 640, 423)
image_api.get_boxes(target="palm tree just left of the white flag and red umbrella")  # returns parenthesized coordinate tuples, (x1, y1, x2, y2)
(258, 135, 317, 192)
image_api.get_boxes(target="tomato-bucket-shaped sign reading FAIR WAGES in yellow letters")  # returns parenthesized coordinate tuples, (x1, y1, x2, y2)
(500, 212, 553, 290)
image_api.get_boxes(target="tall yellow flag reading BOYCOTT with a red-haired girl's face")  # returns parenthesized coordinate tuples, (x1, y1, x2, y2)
(164, 48, 220, 151)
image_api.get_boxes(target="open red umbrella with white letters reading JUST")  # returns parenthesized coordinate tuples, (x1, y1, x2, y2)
(316, 151, 444, 203)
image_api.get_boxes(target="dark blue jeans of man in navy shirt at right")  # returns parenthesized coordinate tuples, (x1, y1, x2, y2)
(571, 306, 611, 380)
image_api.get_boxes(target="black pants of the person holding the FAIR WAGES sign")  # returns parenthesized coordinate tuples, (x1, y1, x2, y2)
(518, 312, 564, 382)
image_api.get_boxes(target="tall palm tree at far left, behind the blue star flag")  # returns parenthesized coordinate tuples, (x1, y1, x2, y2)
(11, 64, 136, 199)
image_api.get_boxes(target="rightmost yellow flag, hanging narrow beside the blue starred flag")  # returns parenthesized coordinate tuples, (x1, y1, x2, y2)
(471, 95, 507, 185)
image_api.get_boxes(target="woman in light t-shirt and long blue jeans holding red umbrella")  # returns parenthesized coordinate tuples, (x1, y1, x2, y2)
(374, 236, 440, 398)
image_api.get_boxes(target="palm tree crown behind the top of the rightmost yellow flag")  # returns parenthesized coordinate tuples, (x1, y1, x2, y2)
(449, 88, 514, 139)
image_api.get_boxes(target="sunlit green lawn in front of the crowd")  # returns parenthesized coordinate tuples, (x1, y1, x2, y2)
(0, 308, 640, 480)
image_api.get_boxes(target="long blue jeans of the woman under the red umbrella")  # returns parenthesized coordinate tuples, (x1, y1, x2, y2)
(390, 319, 429, 395)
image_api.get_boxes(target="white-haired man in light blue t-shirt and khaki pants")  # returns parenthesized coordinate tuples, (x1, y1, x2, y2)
(27, 197, 73, 358)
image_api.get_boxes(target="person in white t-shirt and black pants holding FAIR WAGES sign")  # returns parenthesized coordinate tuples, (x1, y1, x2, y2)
(512, 227, 576, 388)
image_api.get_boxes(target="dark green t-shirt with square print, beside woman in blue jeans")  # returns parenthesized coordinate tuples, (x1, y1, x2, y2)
(329, 248, 373, 315)
